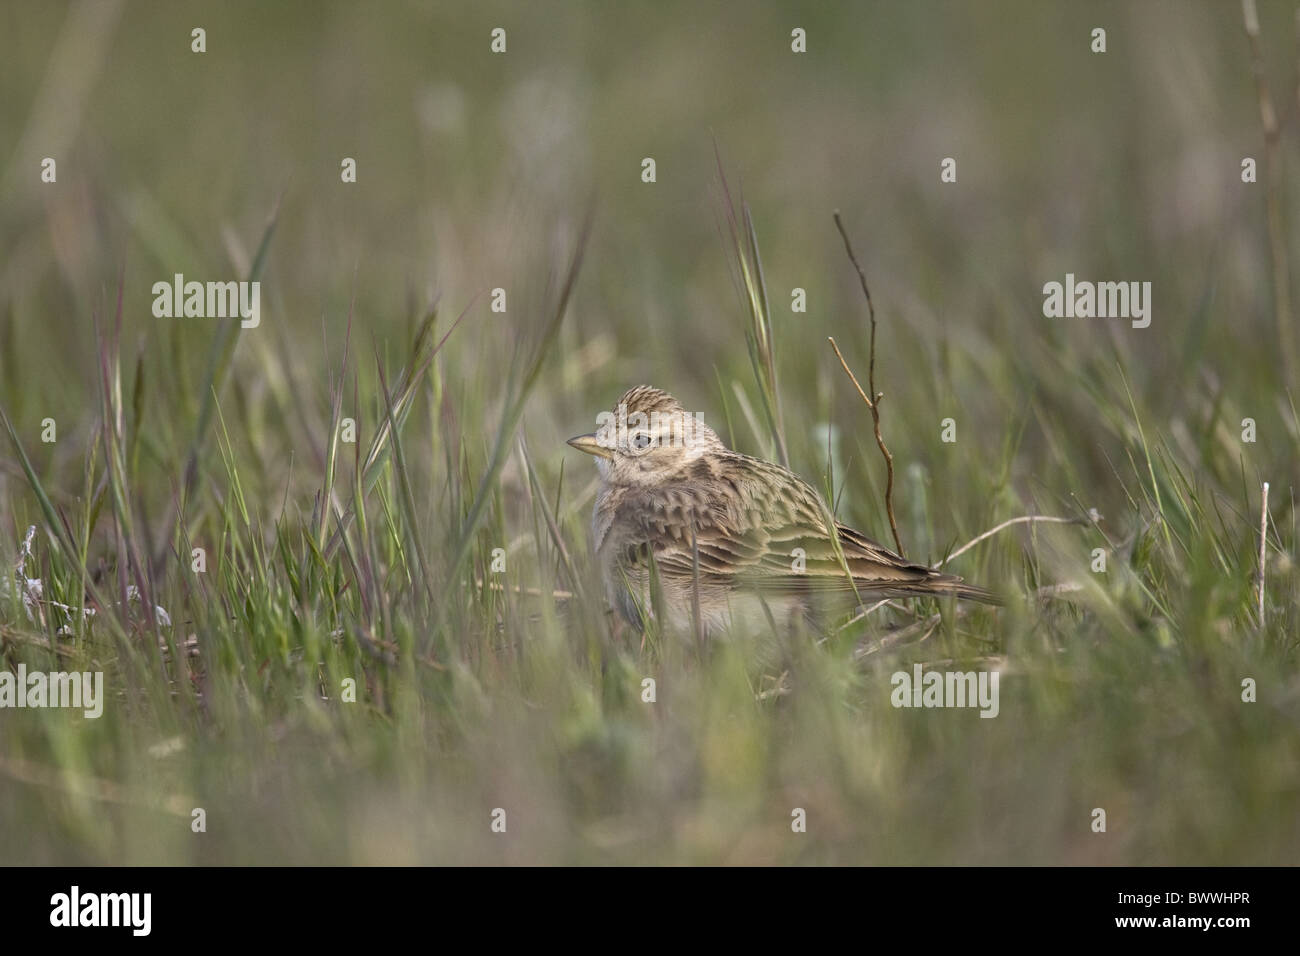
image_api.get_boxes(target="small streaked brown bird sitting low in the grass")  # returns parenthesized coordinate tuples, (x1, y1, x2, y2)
(568, 385, 998, 633)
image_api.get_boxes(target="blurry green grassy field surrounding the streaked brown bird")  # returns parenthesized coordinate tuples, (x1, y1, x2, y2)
(0, 3, 1300, 864)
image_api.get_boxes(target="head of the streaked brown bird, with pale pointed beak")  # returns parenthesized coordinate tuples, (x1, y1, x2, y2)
(568, 385, 725, 485)
